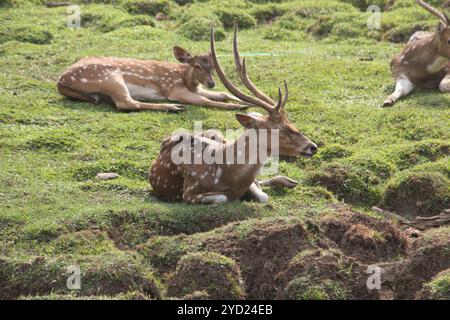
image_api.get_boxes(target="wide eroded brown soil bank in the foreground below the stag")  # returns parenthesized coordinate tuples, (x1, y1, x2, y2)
(138, 205, 444, 299)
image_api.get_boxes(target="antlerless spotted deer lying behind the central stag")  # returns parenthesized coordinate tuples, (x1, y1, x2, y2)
(57, 46, 245, 111)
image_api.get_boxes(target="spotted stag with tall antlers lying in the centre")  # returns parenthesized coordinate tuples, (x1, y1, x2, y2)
(149, 26, 317, 204)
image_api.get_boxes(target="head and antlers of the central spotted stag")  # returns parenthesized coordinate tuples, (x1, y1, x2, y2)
(211, 24, 317, 157)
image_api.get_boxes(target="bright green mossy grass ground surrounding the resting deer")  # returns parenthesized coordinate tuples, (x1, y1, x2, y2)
(0, 0, 450, 298)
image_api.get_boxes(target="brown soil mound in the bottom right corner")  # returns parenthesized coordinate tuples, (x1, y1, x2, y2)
(394, 227, 450, 299)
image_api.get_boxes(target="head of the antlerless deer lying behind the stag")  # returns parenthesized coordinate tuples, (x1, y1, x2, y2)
(173, 46, 216, 89)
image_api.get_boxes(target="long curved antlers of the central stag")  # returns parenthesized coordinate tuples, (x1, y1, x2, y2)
(211, 24, 289, 114)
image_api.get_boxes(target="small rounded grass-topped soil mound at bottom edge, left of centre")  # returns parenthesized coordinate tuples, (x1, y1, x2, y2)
(167, 252, 245, 300)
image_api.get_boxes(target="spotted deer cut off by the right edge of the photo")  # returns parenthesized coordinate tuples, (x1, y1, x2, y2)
(383, 0, 450, 106)
